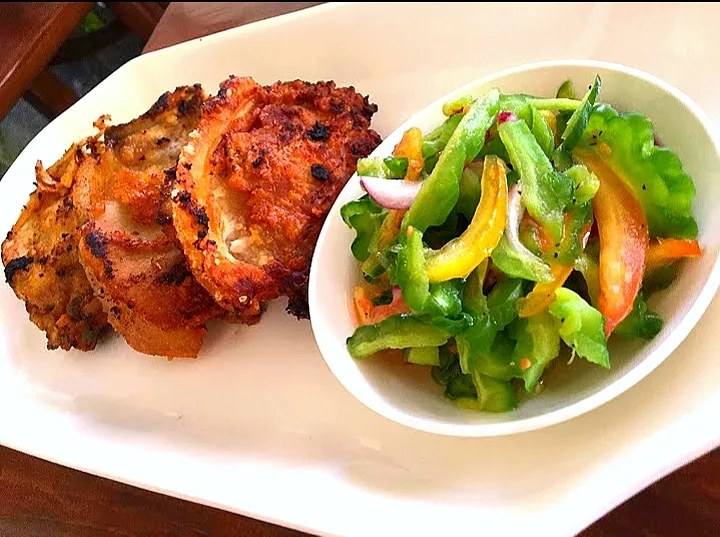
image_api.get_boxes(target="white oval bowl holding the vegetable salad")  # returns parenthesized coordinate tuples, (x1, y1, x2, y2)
(309, 60, 720, 436)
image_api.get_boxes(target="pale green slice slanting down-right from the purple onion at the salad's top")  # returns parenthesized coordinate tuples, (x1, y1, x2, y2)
(500, 120, 573, 242)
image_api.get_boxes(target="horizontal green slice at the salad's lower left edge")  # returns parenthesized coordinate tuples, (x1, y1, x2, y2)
(346, 315, 450, 360)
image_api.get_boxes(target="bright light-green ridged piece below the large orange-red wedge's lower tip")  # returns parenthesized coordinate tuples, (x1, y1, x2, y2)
(548, 287, 610, 369)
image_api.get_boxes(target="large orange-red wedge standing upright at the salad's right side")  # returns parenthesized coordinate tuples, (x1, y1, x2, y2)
(574, 149, 649, 336)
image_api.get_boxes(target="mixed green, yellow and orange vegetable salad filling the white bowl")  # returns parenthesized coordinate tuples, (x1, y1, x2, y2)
(341, 77, 701, 412)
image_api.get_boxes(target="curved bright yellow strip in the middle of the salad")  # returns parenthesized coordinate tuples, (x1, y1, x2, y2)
(427, 155, 508, 283)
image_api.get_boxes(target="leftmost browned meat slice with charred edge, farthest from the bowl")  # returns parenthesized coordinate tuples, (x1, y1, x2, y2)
(2, 143, 107, 351)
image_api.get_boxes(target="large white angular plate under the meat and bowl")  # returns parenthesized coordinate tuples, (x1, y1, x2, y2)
(0, 3, 720, 536)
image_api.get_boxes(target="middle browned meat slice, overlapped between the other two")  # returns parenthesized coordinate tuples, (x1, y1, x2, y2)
(74, 86, 222, 357)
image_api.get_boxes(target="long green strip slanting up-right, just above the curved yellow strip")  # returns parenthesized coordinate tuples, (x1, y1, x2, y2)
(403, 90, 498, 232)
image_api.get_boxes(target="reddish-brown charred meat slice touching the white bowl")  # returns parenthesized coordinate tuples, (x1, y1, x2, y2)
(172, 77, 381, 317)
